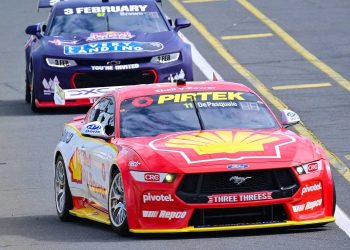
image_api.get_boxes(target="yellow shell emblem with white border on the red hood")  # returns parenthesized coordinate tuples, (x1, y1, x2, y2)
(149, 130, 295, 164)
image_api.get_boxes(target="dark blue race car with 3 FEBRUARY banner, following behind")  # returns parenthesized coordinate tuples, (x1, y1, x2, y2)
(25, 0, 193, 111)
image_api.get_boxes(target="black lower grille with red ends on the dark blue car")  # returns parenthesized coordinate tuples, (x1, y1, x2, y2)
(72, 70, 157, 88)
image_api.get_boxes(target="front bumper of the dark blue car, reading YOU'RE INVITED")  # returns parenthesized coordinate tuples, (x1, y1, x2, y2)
(33, 60, 193, 108)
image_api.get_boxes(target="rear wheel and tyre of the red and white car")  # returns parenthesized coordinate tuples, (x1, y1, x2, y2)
(55, 155, 73, 221)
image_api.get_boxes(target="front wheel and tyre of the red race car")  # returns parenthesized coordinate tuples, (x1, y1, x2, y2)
(108, 172, 129, 236)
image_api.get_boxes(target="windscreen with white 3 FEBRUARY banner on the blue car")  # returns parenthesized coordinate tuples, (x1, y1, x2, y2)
(48, 5, 169, 36)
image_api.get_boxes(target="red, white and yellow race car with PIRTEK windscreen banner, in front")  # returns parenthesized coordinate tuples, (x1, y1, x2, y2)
(54, 81, 335, 234)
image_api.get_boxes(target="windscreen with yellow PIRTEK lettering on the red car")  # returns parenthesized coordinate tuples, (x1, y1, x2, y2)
(120, 91, 279, 138)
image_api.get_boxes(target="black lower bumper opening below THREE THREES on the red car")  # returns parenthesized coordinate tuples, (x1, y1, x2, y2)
(189, 205, 287, 228)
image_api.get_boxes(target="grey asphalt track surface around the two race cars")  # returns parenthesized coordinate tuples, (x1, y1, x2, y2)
(0, 0, 350, 249)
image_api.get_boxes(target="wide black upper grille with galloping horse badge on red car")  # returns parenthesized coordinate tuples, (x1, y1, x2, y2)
(177, 169, 299, 203)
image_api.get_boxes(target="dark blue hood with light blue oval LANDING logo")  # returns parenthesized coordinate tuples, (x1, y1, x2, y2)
(43, 31, 183, 60)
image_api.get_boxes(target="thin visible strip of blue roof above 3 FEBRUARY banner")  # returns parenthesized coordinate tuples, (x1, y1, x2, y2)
(55, 0, 156, 9)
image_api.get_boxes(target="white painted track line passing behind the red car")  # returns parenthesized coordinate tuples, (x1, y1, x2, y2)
(180, 34, 350, 238)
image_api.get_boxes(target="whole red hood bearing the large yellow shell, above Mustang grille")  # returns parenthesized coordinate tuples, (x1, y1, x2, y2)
(122, 129, 322, 173)
